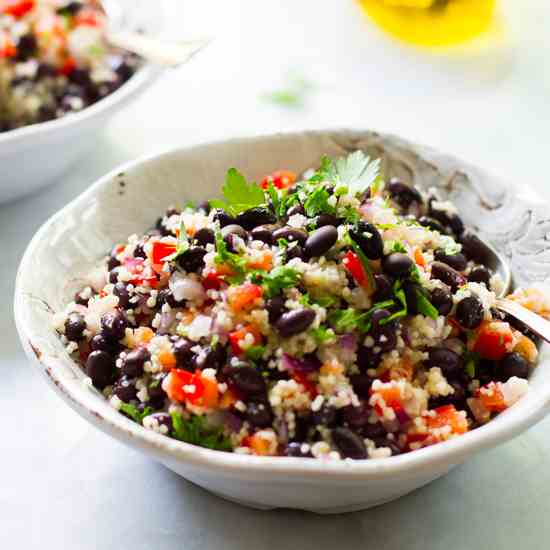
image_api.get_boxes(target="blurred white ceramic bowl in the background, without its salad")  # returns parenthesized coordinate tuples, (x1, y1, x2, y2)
(0, 3, 165, 204)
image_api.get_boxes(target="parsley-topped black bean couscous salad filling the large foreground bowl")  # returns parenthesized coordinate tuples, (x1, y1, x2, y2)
(55, 151, 550, 460)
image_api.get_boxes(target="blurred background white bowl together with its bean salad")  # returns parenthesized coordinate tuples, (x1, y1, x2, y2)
(0, 0, 164, 202)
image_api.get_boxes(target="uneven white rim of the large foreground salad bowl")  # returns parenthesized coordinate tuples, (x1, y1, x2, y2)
(14, 128, 550, 481)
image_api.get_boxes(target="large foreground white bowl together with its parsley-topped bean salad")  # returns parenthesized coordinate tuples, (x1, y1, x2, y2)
(15, 130, 550, 512)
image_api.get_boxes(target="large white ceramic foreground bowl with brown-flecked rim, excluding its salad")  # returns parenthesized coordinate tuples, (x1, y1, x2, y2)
(15, 131, 550, 512)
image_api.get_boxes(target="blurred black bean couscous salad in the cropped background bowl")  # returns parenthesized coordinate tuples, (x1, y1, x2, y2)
(0, 0, 140, 132)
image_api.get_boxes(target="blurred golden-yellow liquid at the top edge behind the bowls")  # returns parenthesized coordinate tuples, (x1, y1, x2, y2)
(358, 0, 496, 47)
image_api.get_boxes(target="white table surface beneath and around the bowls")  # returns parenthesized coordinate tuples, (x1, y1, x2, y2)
(0, 0, 550, 550)
